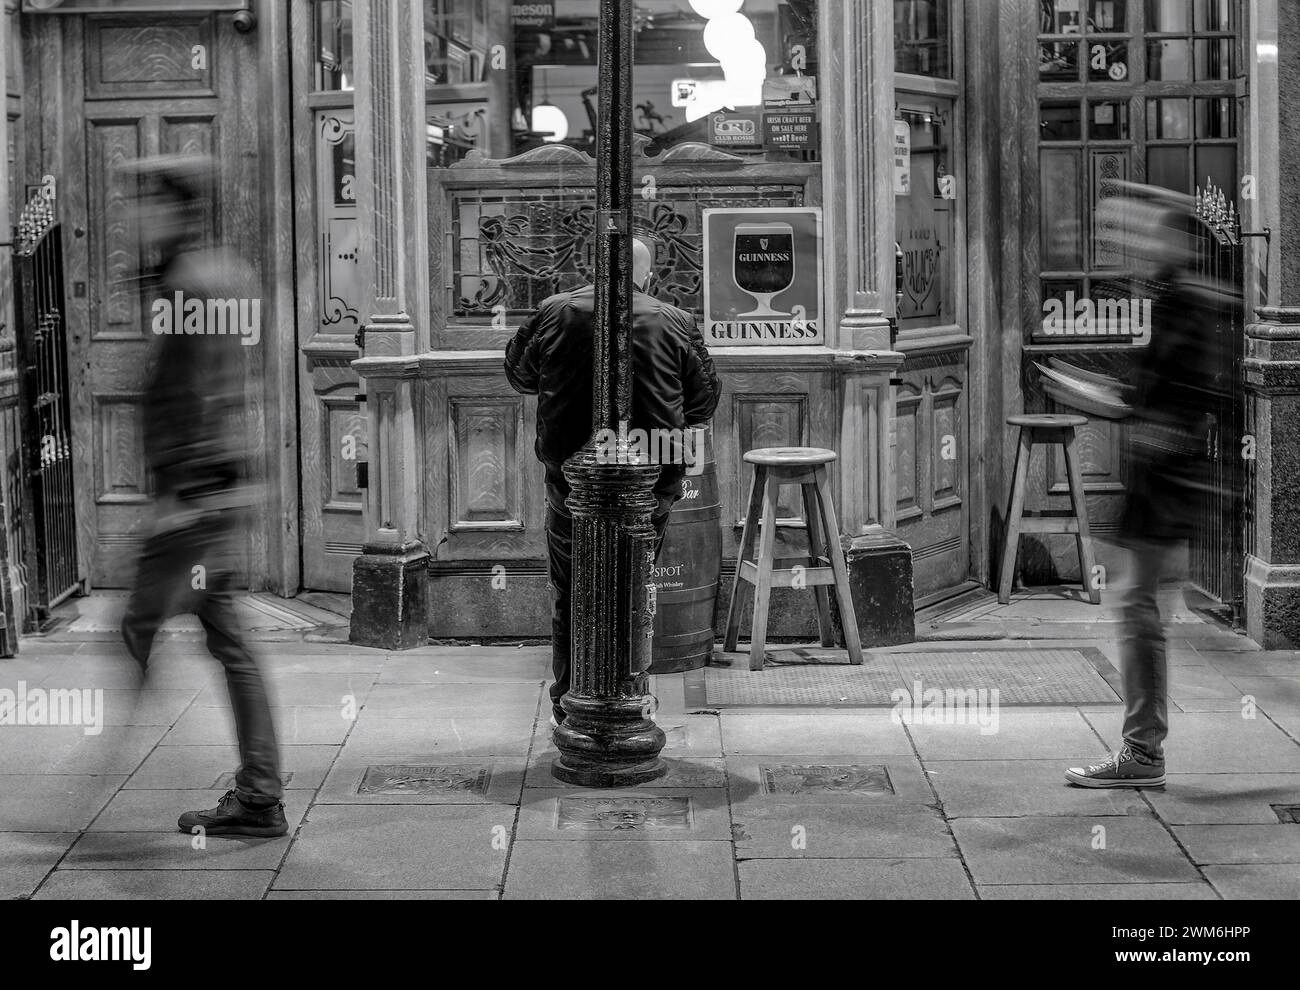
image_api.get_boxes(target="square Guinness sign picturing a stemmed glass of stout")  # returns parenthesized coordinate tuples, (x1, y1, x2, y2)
(705, 207, 826, 346)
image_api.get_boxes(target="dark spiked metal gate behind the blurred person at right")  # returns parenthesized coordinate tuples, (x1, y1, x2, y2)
(1190, 186, 1248, 621)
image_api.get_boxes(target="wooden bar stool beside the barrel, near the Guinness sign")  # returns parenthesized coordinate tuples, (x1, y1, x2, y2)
(723, 447, 862, 670)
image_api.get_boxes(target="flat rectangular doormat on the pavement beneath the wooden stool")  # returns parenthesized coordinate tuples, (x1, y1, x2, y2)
(685, 647, 1121, 709)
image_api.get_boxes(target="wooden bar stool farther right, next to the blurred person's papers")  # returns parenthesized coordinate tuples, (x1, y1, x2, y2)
(997, 413, 1101, 605)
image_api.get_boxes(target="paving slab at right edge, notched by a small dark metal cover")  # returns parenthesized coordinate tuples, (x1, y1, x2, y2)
(1143, 773, 1300, 825)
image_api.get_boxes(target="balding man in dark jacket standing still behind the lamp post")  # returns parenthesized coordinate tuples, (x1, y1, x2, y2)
(506, 239, 722, 725)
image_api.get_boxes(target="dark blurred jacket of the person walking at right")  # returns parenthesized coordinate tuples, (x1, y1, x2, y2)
(1122, 275, 1236, 539)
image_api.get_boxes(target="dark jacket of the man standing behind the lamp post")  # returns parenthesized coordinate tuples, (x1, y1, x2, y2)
(506, 287, 722, 481)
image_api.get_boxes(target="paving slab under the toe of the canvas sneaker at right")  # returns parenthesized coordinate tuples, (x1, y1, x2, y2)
(926, 760, 1151, 819)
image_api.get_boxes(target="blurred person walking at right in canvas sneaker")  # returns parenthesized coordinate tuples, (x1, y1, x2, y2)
(1066, 187, 1231, 787)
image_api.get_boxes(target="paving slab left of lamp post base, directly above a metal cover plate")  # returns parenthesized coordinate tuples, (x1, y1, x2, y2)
(343, 711, 533, 763)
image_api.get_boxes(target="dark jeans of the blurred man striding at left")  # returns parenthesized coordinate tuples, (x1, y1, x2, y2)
(122, 512, 283, 807)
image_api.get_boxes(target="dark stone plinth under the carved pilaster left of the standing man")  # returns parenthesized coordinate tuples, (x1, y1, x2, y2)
(348, 542, 429, 650)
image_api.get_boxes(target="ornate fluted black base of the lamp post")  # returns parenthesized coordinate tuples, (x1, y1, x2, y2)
(551, 440, 667, 787)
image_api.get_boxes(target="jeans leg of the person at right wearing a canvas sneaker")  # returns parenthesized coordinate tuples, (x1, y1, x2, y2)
(1121, 539, 1173, 765)
